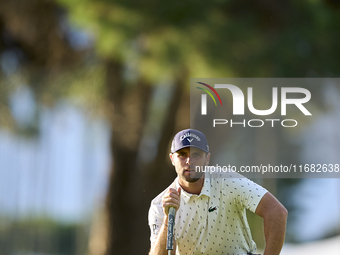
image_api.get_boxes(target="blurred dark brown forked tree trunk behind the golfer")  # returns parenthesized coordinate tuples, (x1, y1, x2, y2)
(105, 60, 190, 255)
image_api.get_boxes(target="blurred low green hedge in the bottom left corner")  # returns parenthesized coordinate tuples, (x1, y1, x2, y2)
(0, 218, 85, 255)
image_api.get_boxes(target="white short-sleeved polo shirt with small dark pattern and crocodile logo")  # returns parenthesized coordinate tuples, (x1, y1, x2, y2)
(149, 174, 267, 255)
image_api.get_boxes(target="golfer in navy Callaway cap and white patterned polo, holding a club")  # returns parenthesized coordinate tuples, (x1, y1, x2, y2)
(149, 129, 287, 255)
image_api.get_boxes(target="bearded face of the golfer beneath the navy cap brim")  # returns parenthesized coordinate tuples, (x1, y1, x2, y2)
(170, 147, 210, 182)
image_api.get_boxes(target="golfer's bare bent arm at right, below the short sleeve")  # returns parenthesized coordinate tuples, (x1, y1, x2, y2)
(255, 192, 288, 255)
